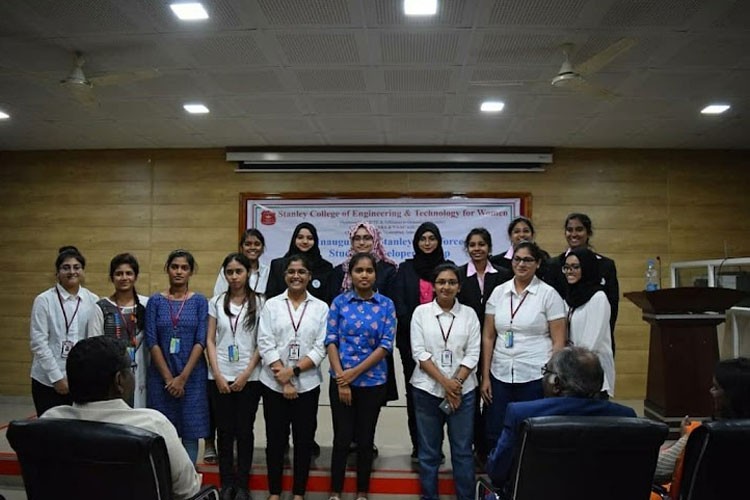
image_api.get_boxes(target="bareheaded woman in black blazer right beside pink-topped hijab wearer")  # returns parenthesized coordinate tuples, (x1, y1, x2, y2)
(457, 227, 513, 463)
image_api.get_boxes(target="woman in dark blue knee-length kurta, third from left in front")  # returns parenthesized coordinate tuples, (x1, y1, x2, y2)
(146, 250, 208, 463)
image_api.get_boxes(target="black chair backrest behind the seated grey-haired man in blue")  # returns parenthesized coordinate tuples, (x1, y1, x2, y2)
(511, 416, 668, 500)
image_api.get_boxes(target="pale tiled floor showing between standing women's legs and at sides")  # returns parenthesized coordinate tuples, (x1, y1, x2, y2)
(0, 396, 643, 500)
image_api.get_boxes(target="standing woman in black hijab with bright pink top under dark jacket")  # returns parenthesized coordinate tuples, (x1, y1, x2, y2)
(393, 222, 445, 461)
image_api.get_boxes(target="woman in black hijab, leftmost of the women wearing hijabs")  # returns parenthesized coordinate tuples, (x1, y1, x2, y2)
(266, 222, 333, 305)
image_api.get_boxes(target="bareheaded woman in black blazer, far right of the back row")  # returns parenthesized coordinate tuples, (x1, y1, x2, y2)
(542, 213, 620, 355)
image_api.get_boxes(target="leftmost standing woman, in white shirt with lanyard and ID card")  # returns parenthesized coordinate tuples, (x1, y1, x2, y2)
(30, 246, 99, 416)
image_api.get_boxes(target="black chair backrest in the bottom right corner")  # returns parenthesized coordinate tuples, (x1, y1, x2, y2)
(679, 419, 750, 500)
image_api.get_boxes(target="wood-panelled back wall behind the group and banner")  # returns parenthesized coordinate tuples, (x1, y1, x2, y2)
(0, 149, 750, 399)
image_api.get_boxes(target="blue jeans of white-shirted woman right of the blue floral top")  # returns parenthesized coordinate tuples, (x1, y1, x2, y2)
(413, 388, 476, 500)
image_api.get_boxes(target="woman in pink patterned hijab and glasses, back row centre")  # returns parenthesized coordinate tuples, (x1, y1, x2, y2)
(328, 221, 398, 408)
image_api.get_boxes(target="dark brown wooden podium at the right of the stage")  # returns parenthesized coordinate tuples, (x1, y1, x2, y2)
(624, 287, 746, 431)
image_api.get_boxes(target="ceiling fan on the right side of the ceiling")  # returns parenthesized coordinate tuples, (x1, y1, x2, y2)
(469, 38, 637, 99)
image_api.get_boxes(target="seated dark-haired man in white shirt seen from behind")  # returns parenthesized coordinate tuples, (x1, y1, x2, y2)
(41, 336, 201, 500)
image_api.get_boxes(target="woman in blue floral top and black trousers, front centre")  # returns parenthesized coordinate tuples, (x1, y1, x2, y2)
(325, 253, 396, 500)
